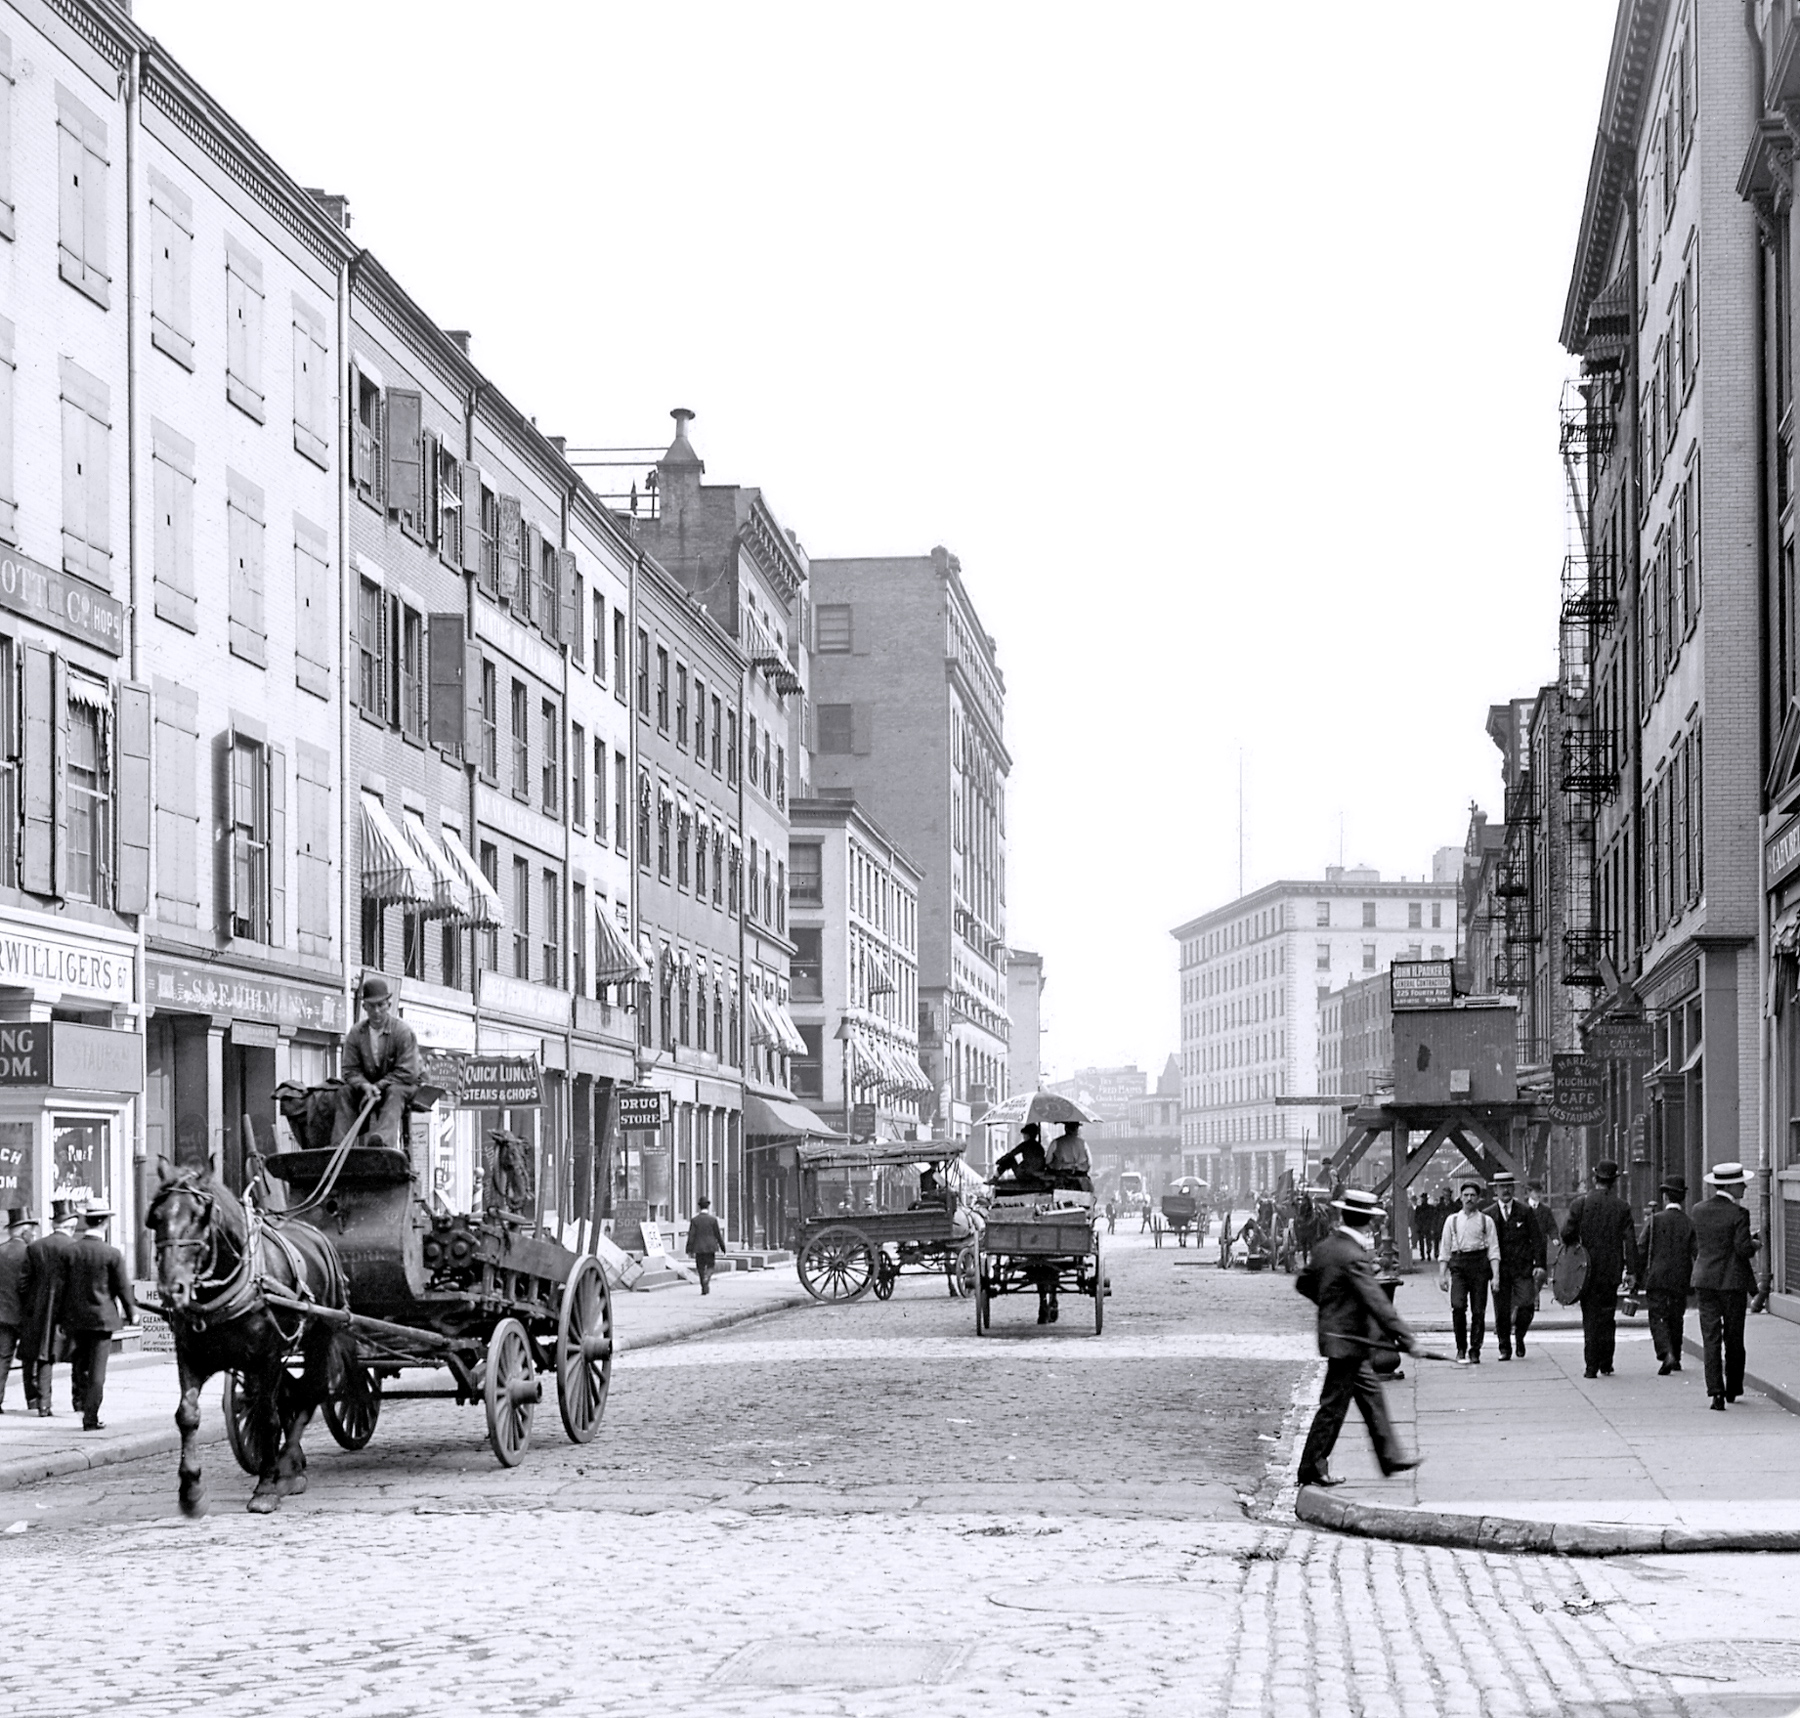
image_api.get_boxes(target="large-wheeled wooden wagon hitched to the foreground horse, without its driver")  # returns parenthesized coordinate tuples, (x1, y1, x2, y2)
(225, 1145, 612, 1473)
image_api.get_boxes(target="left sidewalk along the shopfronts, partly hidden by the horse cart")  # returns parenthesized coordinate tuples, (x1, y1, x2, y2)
(0, 1266, 812, 1491)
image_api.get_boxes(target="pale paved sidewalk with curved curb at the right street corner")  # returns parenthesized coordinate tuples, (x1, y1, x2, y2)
(1296, 1279, 1800, 1556)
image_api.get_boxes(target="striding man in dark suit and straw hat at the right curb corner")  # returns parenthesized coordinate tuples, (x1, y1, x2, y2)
(1294, 1187, 1418, 1486)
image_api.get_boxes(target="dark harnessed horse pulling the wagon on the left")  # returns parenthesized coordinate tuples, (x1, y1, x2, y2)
(144, 1165, 346, 1515)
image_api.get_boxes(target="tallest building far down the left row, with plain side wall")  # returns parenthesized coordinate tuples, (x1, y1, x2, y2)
(810, 549, 1012, 1140)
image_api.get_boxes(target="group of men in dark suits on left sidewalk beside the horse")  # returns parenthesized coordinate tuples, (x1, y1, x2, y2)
(0, 1199, 137, 1432)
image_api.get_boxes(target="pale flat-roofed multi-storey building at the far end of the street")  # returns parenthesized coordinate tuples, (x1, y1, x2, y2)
(1170, 866, 1458, 1192)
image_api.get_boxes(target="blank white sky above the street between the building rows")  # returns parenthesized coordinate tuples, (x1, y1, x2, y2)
(137, 0, 1613, 1073)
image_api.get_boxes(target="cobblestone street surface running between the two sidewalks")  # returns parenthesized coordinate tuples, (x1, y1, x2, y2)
(0, 1235, 1800, 1718)
